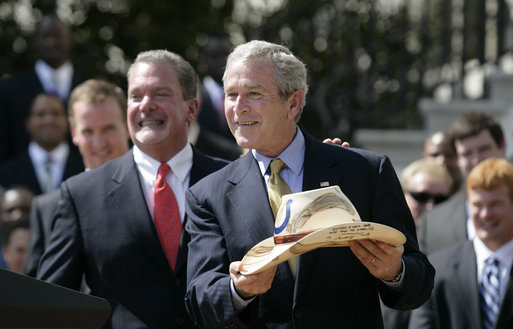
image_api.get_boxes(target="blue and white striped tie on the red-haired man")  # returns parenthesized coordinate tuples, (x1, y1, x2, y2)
(480, 257, 501, 329)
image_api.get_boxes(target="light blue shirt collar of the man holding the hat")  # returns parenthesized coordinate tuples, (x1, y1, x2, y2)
(251, 127, 305, 176)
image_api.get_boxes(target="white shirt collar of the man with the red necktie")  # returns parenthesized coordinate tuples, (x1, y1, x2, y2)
(133, 143, 193, 185)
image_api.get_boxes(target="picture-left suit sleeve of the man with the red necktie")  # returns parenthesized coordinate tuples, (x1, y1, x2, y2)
(37, 182, 84, 290)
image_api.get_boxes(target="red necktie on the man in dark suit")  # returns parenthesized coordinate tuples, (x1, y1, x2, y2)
(153, 163, 182, 271)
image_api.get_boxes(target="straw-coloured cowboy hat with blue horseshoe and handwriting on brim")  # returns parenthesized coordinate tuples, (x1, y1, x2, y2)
(241, 186, 406, 275)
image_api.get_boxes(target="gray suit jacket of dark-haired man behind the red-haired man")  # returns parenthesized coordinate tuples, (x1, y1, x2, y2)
(419, 184, 468, 255)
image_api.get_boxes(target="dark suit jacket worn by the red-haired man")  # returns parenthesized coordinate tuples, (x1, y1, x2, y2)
(409, 241, 513, 329)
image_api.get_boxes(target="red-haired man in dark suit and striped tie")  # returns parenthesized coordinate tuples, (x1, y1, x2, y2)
(409, 158, 513, 329)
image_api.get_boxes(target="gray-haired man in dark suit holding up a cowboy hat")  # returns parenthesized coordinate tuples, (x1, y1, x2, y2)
(186, 41, 434, 328)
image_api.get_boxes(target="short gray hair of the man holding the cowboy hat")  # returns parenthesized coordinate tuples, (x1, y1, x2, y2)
(223, 40, 308, 114)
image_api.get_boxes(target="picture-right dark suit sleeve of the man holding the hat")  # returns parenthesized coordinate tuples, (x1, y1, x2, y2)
(372, 156, 435, 310)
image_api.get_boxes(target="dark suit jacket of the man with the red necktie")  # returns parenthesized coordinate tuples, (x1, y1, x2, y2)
(37, 151, 225, 329)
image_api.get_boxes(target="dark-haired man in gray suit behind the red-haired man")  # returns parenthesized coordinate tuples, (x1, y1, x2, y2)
(419, 112, 506, 255)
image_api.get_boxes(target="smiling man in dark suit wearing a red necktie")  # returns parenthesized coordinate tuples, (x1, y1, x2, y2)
(37, 50, 225, 329)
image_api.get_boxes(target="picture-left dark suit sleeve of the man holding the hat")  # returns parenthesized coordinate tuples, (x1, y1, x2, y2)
(185, 188, 256, 328)
